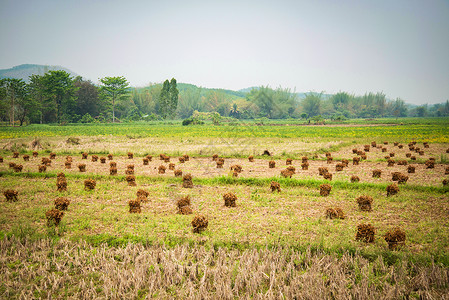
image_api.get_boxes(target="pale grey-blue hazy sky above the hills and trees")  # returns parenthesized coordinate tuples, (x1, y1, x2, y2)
(0, 0, 449, 104)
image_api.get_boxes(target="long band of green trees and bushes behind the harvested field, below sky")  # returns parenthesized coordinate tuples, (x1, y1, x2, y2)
(0, 71, 449, 126)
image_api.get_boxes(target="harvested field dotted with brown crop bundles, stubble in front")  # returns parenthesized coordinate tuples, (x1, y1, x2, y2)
(0, 118, 449, 299)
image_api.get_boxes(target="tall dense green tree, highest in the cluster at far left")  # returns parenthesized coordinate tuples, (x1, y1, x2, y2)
(42, 70, 77, 123)
